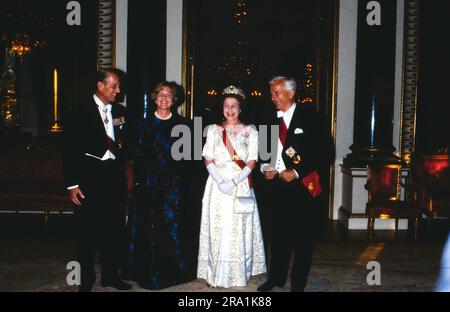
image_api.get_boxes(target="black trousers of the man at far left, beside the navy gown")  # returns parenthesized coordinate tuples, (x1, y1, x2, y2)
(75, 159, 126, 288)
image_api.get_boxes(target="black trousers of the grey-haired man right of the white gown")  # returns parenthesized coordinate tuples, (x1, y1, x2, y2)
(266, 179, 323, 290)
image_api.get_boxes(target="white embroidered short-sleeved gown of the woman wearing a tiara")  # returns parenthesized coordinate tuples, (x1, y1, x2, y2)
(197, 125, 267, 287)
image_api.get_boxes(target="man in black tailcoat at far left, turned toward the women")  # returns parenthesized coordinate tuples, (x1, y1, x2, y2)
(63, 69, 131, 291)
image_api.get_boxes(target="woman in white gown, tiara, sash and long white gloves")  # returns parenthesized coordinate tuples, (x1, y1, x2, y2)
(197, 86, 266, 288)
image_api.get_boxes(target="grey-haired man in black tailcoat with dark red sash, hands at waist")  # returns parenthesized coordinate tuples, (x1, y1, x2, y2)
(258, 77, 329, 292)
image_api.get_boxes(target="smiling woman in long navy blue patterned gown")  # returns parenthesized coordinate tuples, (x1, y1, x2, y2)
(127, 81, 192, 289)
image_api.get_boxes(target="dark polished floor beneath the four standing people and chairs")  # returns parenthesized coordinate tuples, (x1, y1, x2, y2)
(0, 216, 446, 292)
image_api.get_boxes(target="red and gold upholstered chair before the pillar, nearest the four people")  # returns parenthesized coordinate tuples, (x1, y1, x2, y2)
(366, 164, 420, 239)
